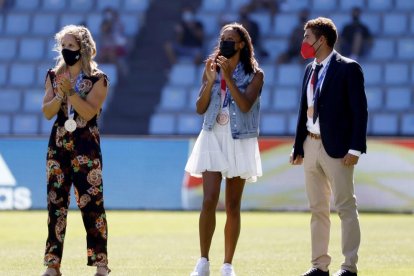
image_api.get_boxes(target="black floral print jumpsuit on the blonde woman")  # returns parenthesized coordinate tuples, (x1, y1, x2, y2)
(44, 70, 109, 266)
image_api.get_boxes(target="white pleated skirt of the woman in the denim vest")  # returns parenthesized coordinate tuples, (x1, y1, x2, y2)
(185, 105, 262, 182)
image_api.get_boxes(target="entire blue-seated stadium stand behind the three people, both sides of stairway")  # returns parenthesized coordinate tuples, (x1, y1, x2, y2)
(0, 0, 414, 136)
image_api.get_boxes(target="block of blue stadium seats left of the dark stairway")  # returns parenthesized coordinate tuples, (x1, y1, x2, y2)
(0, 0, 151, 135)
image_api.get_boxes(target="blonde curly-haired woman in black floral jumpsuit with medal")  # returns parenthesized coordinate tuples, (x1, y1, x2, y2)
(42, 25, 110, 276)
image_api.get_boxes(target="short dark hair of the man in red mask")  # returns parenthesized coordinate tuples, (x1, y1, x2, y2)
(304, 17, 338, 48)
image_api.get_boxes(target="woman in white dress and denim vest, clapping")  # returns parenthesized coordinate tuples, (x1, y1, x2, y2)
(185, 23, 264, 276)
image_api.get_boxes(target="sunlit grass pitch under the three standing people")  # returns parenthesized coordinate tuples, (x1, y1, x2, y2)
(0, 210, 414, 276)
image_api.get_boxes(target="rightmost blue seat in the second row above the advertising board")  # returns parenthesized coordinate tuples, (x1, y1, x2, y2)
(385, 87, 412, 111)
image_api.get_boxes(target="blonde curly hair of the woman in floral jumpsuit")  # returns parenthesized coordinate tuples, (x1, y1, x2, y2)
(53, 25, 98, 77)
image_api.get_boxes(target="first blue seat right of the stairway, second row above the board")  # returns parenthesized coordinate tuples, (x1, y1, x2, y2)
(159, 85, 187, 110)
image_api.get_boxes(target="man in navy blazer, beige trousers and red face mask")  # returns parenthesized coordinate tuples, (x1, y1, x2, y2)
(290, 17, 368, 276)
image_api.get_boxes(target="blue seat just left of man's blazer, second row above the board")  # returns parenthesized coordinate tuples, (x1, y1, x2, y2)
(273, 87, 299, 112)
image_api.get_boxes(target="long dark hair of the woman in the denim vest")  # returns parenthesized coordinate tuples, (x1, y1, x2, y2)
(209, 22, 259, 74)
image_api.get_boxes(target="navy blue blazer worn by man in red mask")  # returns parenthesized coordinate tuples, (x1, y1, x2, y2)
(293, 52, 368, 158)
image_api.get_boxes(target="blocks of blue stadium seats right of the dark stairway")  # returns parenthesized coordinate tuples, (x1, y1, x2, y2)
(149, 0, 414, 136)
